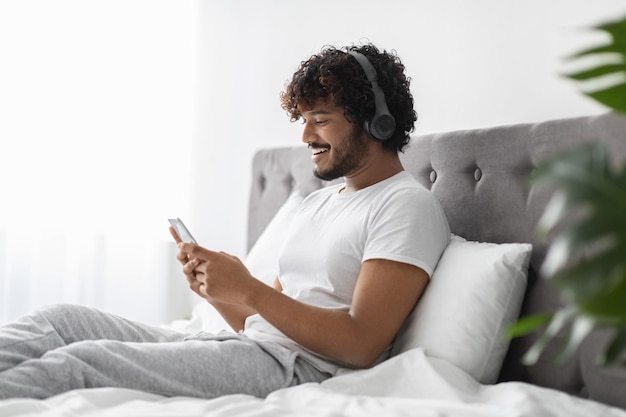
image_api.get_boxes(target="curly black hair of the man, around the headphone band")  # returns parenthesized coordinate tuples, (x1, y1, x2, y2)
(280, 43, 417, 152)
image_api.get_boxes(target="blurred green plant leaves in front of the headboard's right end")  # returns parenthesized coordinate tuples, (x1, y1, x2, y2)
(509, 12, 626, 364)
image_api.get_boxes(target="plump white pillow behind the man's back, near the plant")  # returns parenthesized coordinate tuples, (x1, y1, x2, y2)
(391, 235, 532, 384)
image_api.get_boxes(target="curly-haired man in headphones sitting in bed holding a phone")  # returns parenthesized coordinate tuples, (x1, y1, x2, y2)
(0, 45, 449, 398)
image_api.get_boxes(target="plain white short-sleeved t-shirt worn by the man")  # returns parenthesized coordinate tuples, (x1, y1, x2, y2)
(244, 171, 450, 374)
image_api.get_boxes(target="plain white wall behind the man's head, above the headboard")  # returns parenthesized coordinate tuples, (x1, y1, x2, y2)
(190, 0, 626, 256)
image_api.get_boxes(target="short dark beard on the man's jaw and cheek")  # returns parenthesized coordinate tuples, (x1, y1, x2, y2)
(313, 127, 369, 181)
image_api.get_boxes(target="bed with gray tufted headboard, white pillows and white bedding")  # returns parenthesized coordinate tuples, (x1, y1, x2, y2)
(0, 113, 626, 417)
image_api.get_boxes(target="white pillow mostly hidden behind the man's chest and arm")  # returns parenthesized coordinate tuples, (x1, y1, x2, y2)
(244, 191, 304, 285)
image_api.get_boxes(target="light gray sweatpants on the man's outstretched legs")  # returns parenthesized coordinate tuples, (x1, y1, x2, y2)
(0, 304, 330, 398)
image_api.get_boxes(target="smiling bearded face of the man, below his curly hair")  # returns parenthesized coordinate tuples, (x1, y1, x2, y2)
(301, 104, 369, 181)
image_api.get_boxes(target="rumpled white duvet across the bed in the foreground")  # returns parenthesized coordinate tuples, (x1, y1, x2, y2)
(0, 349, 626, 417)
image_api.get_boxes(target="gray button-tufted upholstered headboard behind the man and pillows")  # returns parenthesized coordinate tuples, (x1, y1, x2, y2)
(248, 114, 626, 408)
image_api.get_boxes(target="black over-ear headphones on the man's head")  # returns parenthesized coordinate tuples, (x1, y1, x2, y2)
(348, 51, 396, 142)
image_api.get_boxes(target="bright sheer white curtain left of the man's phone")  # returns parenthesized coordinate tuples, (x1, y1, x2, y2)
(0, 0, 196, 324)
